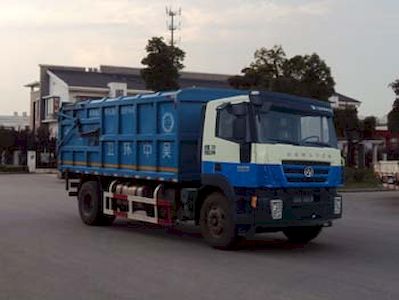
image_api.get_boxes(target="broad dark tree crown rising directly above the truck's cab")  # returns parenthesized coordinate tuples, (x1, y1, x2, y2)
(229, 46, 335, 101)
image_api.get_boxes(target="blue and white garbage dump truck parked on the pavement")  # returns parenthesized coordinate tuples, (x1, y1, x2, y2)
(58, 88, 343, 249)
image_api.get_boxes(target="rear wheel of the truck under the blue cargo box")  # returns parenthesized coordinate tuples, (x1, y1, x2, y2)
(78, 181, 115, 226)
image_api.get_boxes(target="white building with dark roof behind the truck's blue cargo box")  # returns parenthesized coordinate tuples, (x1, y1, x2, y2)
(25, 65, 230, 136)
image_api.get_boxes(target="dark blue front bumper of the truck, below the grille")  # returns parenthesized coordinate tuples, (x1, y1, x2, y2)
(236, 189, 342, 232)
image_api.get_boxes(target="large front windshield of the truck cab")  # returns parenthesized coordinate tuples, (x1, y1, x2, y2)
(256, 110, 337, 148)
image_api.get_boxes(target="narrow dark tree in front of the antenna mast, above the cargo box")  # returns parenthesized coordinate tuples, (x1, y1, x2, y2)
(141, 37, 185, 91)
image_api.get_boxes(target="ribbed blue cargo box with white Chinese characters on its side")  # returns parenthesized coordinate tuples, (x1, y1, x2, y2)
(58, 88, 248, 182)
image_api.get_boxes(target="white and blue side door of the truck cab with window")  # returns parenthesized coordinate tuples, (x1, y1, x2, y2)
(202, 96, 257, 187)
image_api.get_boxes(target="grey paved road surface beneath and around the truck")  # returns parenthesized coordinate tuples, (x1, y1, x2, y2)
(0, 175, 399, 300)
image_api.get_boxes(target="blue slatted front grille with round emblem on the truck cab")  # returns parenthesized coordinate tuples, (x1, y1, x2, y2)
(283, 161, 331, 183)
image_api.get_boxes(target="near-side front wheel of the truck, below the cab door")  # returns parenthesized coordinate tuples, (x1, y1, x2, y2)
(200, 193, 237, 250)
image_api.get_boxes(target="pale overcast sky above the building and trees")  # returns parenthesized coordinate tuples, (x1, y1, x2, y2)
(0, 0, 399, 116)
